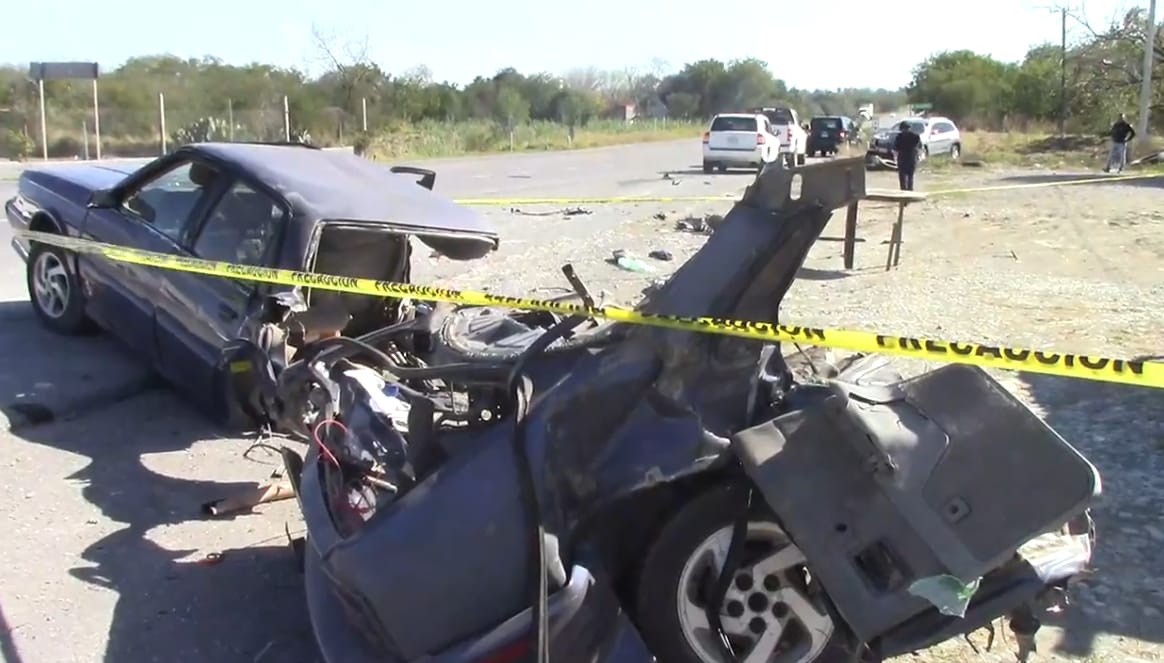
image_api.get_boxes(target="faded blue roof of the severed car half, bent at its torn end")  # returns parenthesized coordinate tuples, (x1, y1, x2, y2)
(179, 143, 497, 251)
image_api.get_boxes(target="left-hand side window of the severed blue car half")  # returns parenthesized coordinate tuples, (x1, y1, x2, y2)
(121, 162, 220, 242)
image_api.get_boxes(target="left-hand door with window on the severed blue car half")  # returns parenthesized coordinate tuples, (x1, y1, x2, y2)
(78, 157, 224, 365)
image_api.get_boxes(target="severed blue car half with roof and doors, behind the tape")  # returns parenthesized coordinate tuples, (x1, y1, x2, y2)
(5, 143, 498, 419)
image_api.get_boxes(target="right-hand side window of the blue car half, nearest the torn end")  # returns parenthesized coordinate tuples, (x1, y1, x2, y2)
(191, 181, 286, 266)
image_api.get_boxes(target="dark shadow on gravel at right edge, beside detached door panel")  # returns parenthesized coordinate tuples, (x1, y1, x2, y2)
(1021, 373, 1164, 661)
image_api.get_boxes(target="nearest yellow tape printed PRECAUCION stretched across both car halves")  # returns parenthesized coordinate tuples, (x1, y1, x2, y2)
(17, 230, 1164, 387)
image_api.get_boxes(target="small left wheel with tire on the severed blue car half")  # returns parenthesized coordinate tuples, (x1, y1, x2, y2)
(24, 242, 94, 336)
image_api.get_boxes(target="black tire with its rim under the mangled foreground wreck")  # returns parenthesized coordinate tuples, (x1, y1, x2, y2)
(636, 479, 867, 663)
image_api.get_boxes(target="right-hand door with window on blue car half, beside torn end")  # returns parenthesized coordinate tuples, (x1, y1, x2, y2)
(156, 176, 289, 409)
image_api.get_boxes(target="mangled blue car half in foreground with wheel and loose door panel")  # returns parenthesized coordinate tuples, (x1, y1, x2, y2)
(270, 158, 1100, 663)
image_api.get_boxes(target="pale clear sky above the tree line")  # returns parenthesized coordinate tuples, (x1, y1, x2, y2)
(0, 0, 1147, 88)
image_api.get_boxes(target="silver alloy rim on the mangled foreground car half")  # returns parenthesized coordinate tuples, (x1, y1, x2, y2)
(675, 521, 835, 663)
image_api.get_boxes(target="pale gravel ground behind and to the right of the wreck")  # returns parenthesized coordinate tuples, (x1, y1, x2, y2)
(419, 167, 1164, 663)
